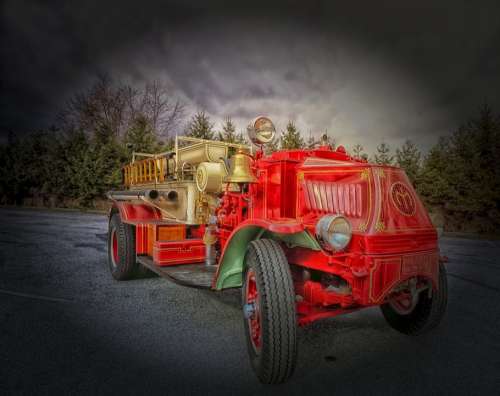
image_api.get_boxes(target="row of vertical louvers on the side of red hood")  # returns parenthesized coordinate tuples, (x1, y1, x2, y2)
(304, 180, 363, 217)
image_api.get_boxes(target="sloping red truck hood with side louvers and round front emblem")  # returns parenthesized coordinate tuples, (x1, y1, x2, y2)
(296, 158, 437, 251)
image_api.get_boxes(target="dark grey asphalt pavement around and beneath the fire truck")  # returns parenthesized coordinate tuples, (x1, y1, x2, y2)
(0, 209, 500, 395)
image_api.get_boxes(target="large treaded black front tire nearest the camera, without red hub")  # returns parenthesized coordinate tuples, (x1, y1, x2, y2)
(242, 239, 297, 384)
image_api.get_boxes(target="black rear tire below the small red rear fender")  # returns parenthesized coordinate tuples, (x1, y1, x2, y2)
(108, 213, 139, 280)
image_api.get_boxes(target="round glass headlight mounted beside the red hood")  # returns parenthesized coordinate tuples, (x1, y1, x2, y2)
(316, 215, 352, 252)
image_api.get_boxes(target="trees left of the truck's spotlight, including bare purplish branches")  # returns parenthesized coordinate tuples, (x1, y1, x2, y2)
(0, 76, 245, 208)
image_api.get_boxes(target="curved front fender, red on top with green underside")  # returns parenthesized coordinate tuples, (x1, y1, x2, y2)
(213, 220, 321, 290)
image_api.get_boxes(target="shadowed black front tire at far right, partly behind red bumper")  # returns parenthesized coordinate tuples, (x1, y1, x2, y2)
(380, 263, 448, 336)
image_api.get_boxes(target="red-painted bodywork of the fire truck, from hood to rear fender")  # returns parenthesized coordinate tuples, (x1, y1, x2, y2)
(116, 147, 439, 324)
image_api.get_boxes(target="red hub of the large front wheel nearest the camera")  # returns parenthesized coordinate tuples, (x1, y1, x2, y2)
(244, 269, 262, 352)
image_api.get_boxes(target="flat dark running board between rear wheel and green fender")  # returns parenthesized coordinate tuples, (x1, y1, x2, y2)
(137, 256, 217, 289)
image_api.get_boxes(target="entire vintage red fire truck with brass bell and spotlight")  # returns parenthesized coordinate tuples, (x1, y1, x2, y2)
(108, 117, 447, 383)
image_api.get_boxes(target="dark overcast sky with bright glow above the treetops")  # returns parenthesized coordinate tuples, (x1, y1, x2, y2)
(0, 0, 500, 151)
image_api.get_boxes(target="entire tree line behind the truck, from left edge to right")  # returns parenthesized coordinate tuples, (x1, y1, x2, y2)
(0, 76, 500, 233)
